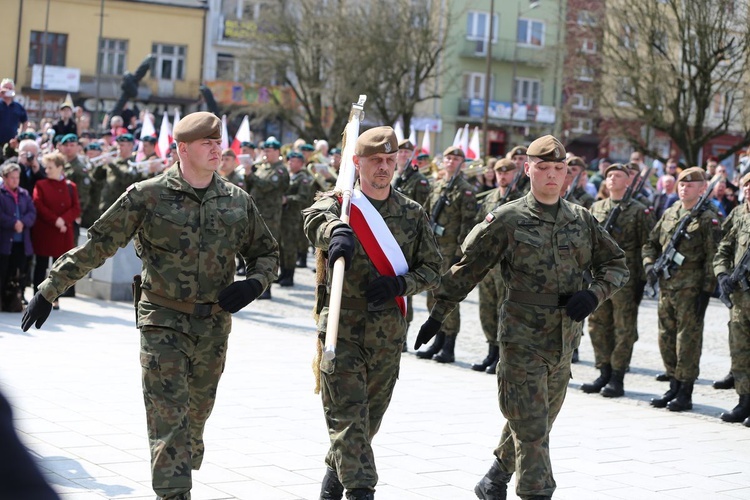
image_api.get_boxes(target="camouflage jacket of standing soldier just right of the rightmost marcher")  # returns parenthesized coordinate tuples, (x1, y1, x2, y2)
(591, 198, 654, 282)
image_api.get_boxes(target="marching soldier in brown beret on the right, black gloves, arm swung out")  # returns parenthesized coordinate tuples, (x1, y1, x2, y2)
(415, 135, 628, 500)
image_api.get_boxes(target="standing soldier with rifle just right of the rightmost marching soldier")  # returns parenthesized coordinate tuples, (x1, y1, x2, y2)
(581, 163, 654, 398)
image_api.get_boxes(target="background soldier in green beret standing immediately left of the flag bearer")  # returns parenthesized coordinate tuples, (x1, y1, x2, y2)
(279, 151, 315, 286)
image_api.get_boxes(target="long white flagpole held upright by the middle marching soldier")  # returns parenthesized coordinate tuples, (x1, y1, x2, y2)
(323, 95, 367, 360)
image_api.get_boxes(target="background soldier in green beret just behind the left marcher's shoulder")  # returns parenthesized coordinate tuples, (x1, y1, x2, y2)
(245, 139, 289, 299)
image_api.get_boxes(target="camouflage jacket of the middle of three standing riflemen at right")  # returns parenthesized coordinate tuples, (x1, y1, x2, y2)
(643, 201, 721, 293)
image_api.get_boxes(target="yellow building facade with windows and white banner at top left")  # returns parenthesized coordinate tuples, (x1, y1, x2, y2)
(0, 0, 206, 123)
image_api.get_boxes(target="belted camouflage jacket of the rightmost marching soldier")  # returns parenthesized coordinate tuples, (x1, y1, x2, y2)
(430, 193, 628, 352)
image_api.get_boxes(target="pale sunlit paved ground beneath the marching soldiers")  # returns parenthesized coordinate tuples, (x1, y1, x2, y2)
(0, 269, 750, 500)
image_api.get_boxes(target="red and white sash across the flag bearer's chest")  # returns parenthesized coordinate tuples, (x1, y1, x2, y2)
(349, 189, 409, 316)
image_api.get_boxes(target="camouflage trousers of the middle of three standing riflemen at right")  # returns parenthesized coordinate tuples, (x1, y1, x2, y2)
(658, 286, 703, 382)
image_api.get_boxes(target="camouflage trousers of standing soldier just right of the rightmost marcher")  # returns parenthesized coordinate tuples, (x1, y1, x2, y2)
(589, 282, 638, 372)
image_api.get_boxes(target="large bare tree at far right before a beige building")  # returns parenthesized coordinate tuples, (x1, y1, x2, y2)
(600, 0, 750, 165)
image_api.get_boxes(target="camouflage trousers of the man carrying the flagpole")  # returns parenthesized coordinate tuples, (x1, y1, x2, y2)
(318, 308, 406, 490)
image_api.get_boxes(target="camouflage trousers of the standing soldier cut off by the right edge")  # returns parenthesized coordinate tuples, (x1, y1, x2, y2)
(729, 290, 750, 394)
